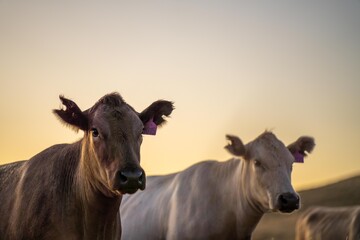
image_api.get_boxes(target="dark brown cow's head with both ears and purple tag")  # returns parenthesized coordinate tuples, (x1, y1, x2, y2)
(54, 93, 173, 194)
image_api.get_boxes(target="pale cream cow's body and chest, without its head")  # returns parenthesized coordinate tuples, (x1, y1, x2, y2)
(121, 159, 263, 240)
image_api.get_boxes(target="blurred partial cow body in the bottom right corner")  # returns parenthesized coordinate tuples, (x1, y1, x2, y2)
(296, 206, 360, 240)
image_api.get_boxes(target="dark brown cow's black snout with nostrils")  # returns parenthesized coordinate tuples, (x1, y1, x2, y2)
(117, 168, 145, 194)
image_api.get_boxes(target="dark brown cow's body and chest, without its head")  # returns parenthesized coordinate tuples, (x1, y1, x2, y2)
(0, 142, 121, 240)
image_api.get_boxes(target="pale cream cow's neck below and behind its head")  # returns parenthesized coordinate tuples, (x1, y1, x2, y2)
(230, 160, 264, 236)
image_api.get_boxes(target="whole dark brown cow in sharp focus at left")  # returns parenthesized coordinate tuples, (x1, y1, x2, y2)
(0, 93, 173, 240)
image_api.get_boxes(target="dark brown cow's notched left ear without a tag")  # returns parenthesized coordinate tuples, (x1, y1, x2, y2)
(53, 96, 89, 131)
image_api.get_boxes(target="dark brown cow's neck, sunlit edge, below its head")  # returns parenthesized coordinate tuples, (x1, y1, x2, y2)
(77, 142, 121, 239)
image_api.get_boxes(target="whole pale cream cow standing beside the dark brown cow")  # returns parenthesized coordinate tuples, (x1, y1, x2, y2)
(120, 132, 314, 240)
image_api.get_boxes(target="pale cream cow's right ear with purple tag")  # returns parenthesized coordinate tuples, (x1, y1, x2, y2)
(287, 136, 315, 163)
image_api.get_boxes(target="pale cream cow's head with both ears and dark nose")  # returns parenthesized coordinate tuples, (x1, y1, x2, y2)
(225, 132, 315, 212)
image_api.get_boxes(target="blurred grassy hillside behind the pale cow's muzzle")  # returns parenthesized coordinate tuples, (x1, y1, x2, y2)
(253, 176, 360, 240)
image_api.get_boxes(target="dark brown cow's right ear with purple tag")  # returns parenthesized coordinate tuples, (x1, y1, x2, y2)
(139, 100, 174, 135)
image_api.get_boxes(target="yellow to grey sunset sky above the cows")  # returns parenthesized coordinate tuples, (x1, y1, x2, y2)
(0, 0, 360, 190)
